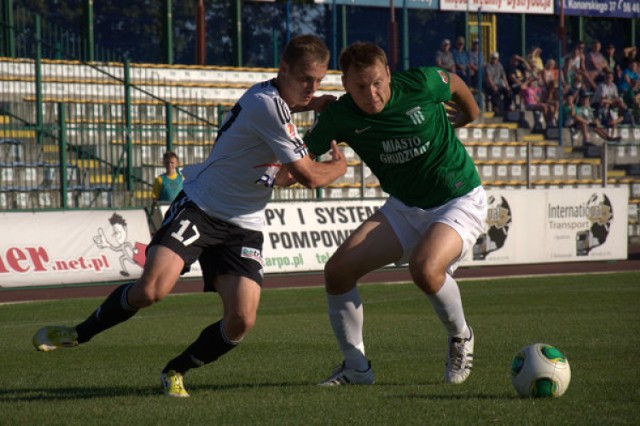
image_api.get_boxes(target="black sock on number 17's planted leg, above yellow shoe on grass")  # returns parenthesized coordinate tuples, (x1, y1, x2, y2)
(162, 320, 239, 374)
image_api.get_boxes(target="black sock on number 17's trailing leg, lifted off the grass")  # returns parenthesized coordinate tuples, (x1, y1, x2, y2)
(76, 283, 138, 343)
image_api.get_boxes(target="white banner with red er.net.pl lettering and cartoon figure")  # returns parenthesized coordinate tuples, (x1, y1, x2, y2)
(0, 210, 150, 288)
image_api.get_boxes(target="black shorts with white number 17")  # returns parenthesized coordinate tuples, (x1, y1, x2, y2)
(149, 192, 263, 291)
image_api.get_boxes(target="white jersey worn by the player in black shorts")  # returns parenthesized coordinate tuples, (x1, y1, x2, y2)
(182, 80, 307, 231)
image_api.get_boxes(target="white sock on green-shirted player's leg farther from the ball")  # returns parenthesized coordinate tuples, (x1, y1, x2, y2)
(327, 287, 369, 371)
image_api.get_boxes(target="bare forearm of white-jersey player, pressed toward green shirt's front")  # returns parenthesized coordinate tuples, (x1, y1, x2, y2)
(284, 141, 347, 189)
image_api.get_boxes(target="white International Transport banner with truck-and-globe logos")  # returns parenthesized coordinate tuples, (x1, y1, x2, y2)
(462, 187, 629, 266)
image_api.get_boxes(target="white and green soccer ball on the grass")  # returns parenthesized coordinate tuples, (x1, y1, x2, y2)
(511, 343, 571, 398)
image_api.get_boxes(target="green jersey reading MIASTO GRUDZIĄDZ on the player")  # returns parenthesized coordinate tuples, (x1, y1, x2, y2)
(304, 67, 481, 208)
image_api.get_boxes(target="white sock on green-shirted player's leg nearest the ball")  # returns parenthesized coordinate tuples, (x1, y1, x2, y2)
(427, 274, 470, 338)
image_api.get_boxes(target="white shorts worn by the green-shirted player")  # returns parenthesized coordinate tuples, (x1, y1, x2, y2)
(380, 186, 487, 274)
